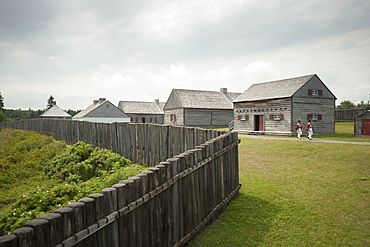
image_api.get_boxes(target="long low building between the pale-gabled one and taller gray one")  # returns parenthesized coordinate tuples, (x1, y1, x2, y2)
(118, 99, 166, 124)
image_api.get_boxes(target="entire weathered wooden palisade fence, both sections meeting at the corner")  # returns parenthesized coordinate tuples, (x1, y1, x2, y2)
(0, 119, 240, 247)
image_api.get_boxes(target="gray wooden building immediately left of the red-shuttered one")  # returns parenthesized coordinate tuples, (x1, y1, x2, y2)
(164, 88, 240, 128)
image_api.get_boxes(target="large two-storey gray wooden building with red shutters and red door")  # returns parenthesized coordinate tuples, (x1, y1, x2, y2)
(234, 74, 336, 135)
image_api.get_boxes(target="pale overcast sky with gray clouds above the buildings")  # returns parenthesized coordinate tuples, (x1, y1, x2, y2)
(0, 0, 370, 110)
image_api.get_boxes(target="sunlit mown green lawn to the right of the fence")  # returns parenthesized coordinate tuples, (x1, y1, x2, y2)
(189, 123, 370, 247)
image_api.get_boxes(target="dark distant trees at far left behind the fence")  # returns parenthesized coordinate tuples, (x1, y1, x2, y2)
(0, 92, 80, 122)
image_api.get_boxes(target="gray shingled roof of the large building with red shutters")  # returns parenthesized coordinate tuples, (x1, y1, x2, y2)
(234, 74, 316, 102)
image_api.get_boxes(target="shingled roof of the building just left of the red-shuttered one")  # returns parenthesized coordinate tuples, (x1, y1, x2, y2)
(165, 89, 240, 109)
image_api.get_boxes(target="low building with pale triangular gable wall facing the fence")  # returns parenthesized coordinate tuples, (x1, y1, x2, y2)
(72, 98, 130, 123)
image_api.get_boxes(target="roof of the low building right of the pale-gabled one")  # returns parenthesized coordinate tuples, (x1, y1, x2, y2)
(118, 100, 166, 115)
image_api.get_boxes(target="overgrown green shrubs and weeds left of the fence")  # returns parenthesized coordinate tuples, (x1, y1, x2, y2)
(0, 130, 147, 235)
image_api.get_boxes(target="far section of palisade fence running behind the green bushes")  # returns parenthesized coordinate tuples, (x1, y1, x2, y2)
(0, 119, 223, 166)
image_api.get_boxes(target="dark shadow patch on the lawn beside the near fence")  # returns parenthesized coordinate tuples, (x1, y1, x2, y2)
(188, 193, 279, 247)
